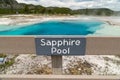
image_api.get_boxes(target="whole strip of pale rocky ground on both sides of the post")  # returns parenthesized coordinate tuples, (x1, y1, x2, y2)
(1, 54, 120, 75)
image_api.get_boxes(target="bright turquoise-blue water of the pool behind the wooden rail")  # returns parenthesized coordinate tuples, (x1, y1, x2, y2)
(0, 21, 103, 35)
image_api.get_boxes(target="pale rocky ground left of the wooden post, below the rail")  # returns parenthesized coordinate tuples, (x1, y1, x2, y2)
(2, 54, 52, 74)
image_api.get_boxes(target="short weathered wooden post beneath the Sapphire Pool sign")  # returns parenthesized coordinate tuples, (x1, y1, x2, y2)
(51, 55, 62, 75)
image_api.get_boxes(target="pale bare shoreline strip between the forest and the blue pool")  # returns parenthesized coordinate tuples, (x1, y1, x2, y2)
(0, 14, 120, 26)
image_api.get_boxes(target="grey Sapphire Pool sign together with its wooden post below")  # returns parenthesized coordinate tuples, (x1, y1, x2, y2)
(35, 37, 86, 75)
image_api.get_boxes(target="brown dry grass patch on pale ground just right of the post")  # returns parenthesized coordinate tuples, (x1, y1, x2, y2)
(65, 61, 93, 75)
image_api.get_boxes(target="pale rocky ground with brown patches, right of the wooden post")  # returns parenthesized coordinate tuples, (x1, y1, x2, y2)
(63, 55, 120, 75)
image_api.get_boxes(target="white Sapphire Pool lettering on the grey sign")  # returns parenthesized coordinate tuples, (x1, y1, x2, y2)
(40, 39, 81, 54)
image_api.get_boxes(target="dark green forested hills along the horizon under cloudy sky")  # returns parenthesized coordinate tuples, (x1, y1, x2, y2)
(0, 0, 120, 16)
